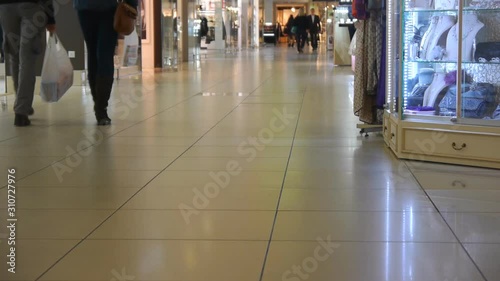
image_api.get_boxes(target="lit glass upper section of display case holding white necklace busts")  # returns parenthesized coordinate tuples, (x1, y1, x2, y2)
(400, 0, 500, 122)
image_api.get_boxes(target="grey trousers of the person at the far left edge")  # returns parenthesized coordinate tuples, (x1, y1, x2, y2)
(0, 3, 47, 115)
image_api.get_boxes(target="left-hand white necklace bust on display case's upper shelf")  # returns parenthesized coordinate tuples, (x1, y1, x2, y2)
(420, 15, 455, 60)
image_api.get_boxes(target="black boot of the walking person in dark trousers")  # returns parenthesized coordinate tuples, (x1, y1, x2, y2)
(94, 76, 114, 126)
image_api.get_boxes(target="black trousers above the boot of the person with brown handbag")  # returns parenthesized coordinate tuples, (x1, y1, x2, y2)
(78, 10, 118, 80)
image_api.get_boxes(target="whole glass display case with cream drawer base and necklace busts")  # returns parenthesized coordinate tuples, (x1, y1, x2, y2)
(384, 0, 500, 168)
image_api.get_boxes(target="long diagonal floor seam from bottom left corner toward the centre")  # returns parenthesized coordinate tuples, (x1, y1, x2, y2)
(35, 65, 280, 281)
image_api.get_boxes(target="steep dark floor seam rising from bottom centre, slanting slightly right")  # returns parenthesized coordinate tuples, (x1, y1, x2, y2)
(259, 73, 312, 281)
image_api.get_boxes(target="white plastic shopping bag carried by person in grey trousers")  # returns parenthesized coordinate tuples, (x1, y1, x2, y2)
(40, 34, 73, 102)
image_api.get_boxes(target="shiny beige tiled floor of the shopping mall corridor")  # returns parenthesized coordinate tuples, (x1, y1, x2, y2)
(0, 48, 500, 281)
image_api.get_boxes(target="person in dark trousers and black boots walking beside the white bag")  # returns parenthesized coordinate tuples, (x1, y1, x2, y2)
(73, 0, 137, 126)
